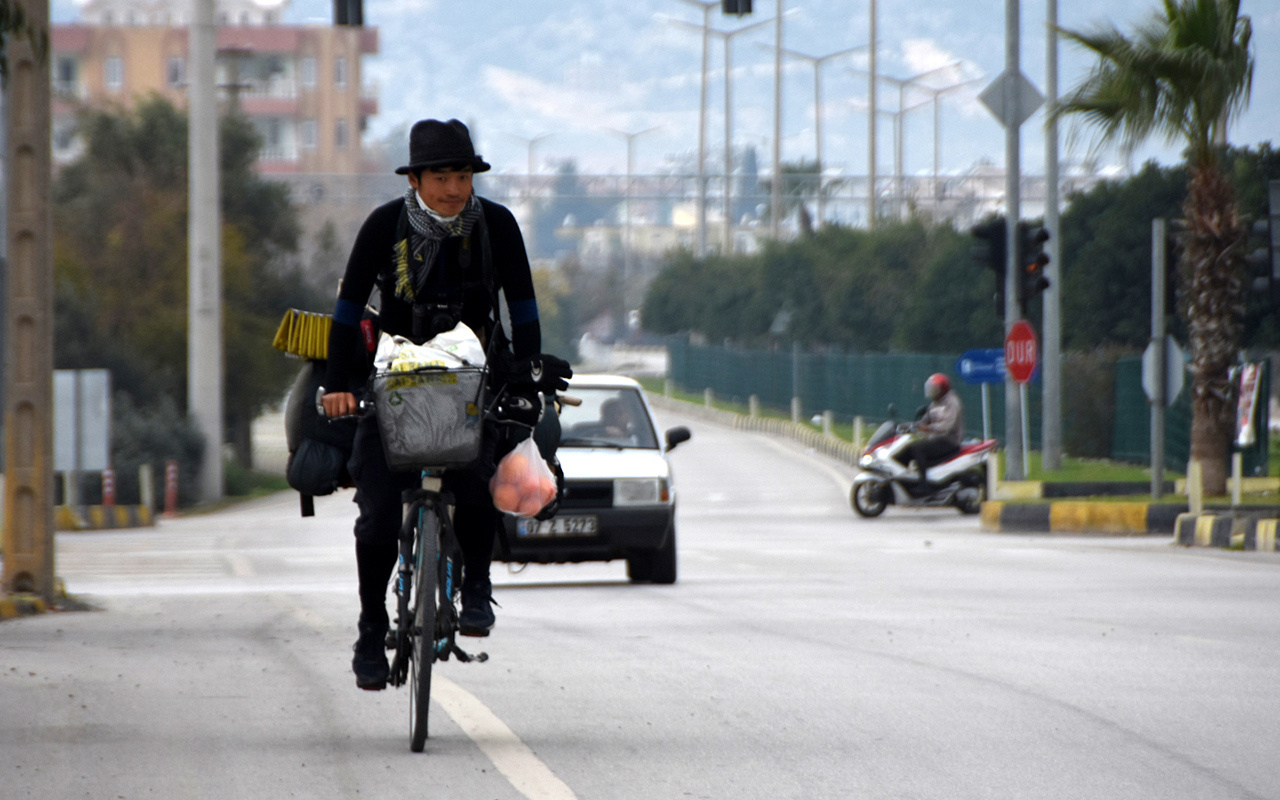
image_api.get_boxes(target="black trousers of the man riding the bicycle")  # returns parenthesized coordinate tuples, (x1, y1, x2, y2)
(347, 416, 502, 627)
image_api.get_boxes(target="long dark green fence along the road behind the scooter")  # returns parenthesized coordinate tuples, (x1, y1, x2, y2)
(668, 339, 1270, 475)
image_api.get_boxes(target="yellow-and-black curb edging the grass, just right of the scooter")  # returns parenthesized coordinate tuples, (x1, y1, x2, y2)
(982, 500, 1187, 536)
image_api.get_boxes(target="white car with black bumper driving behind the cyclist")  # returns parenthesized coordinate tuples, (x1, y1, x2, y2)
(495, 375, 690, 584)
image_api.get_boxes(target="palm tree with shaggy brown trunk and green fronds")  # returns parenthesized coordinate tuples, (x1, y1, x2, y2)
(1059, 0, 1253, 494)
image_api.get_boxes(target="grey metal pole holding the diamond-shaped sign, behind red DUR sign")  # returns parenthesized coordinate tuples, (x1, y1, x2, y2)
(1004, 0, 1027, 480)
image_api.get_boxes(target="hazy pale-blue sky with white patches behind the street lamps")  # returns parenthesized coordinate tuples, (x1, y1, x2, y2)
(52, 0, 1280, 180)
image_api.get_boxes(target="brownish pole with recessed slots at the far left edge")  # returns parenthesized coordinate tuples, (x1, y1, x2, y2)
(0, 0, 54, 600)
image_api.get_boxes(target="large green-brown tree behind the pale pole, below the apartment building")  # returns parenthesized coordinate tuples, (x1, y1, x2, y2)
(52, 97, 320, 476)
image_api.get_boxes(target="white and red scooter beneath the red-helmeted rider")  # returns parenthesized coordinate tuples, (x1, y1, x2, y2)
(849, 420, 996, 517)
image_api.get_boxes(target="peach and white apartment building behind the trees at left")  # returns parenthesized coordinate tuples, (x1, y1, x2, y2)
(51, 0, 378, 177)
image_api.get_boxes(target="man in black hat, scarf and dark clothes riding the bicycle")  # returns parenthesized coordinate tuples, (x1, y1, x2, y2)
(321, 119, 572, 690)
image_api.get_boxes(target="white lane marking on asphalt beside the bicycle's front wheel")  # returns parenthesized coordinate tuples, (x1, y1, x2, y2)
(431, 675, 577, 800)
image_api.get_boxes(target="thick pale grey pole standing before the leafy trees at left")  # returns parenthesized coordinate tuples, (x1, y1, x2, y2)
(187, 0, 223, 502)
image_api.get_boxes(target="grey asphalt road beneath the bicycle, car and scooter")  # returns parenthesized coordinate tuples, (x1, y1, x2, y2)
(0, 415, 1280, 800)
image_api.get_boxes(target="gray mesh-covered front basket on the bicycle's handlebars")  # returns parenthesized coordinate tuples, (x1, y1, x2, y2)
(372, 367, 485, 470)
